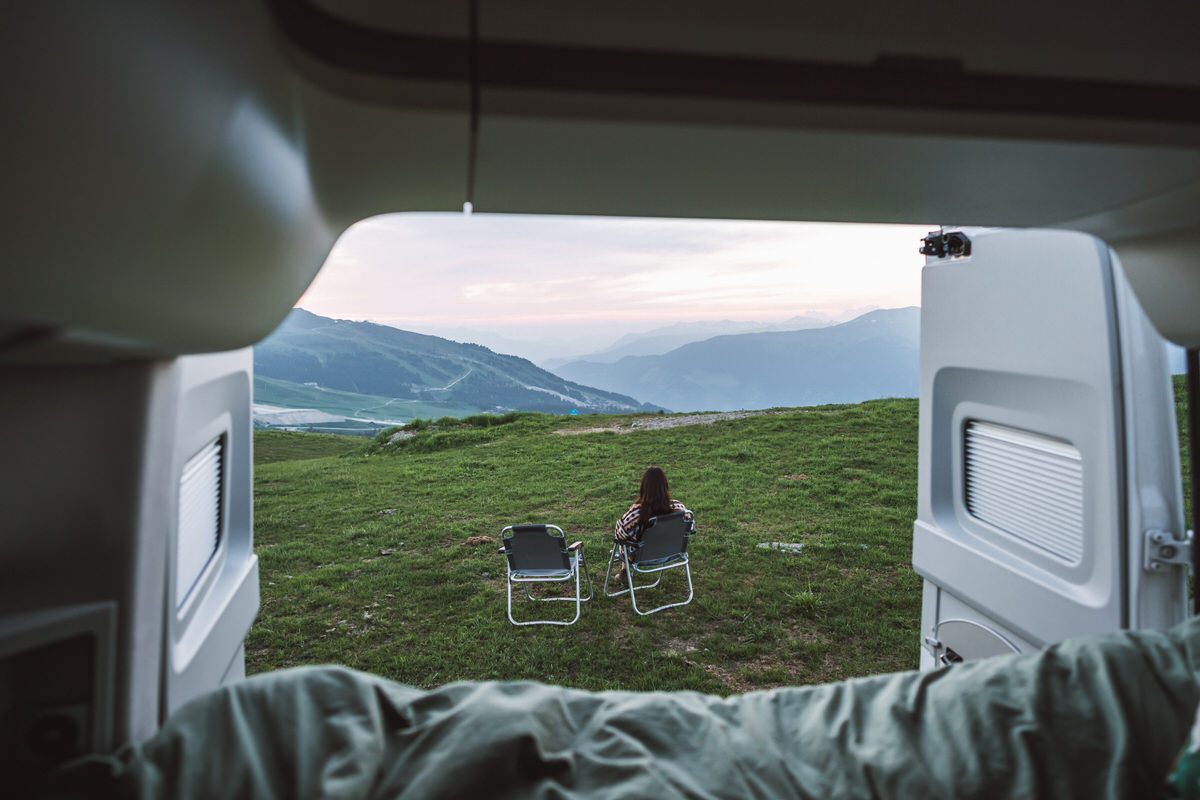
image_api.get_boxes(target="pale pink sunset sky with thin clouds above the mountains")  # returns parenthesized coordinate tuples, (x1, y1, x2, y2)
(296, 213, 930, 357)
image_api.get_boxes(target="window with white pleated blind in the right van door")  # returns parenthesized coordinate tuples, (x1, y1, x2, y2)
(964, 422, 1084, 564)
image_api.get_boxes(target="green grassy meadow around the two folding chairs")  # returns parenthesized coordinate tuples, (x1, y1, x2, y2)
(246, 401, 920, 693)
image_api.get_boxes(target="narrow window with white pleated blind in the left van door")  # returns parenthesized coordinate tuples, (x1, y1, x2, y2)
(175, 437, 224, 608)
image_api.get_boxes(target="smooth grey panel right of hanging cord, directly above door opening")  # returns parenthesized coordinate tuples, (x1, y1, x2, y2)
(475, 110, 1200, 227)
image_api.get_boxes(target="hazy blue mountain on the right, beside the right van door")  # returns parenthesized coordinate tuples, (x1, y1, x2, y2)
(556, 308, 920, 411)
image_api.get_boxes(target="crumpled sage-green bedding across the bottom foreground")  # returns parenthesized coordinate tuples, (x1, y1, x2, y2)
(46, 621, 1200, 800)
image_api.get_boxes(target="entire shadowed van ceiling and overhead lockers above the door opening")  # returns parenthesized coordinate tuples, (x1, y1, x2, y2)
(7, 0, 1200, 361)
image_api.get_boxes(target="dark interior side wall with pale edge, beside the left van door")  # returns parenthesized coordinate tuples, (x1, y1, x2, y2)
(0, 361, 178, 742)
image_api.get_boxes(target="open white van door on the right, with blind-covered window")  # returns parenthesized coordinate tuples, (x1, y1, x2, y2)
(913, 230, 1187, 668)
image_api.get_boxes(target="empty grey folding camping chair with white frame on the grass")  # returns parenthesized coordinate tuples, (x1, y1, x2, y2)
(499, 524, 592, 625)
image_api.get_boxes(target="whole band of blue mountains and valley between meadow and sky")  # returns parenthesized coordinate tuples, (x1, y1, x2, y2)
(254, 308, 920, 434)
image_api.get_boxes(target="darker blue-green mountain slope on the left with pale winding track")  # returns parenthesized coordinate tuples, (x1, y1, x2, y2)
(254, 308, 656, 414)
